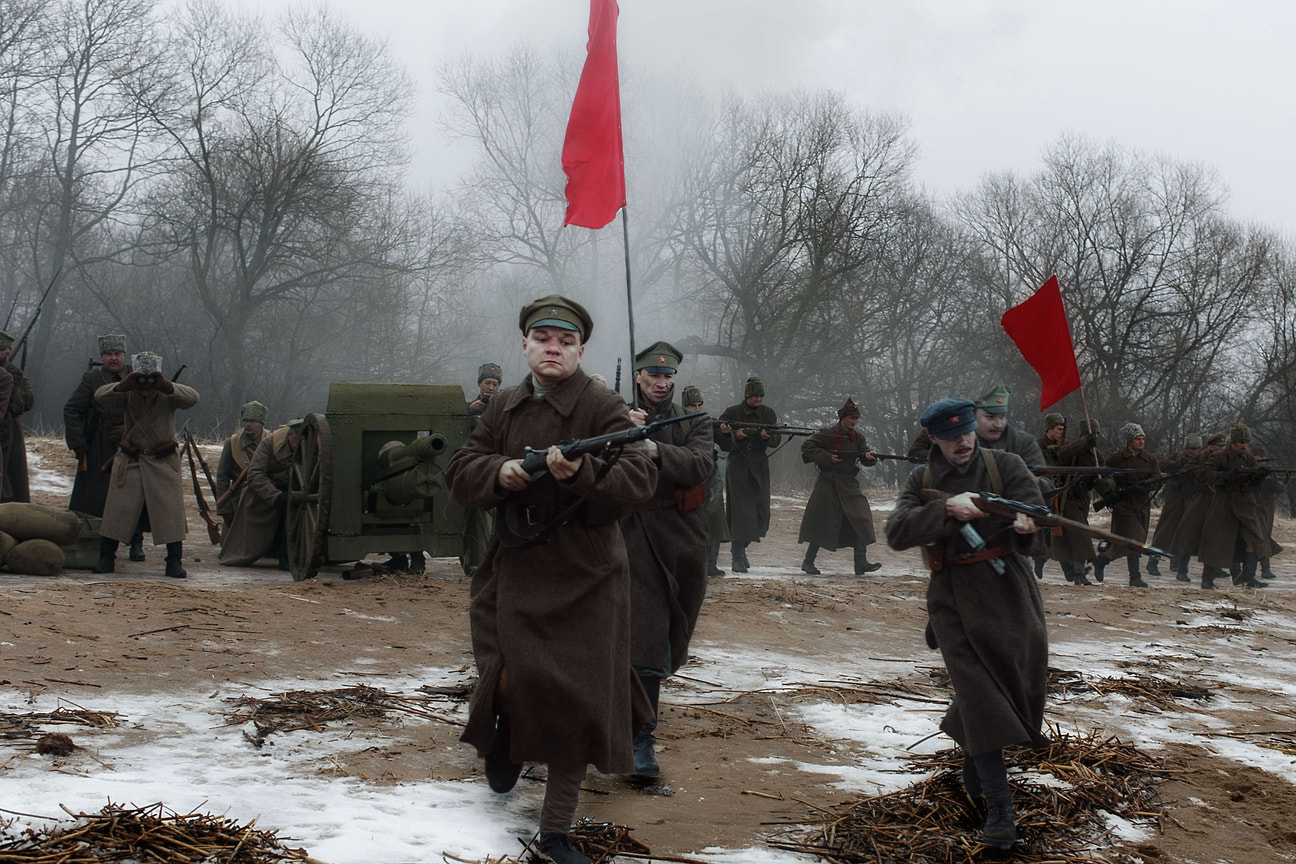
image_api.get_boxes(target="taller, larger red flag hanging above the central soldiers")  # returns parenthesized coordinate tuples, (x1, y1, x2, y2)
(562, 0, 626, 228)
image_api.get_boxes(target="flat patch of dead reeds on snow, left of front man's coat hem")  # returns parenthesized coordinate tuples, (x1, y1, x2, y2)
(223, 684, 463, 749)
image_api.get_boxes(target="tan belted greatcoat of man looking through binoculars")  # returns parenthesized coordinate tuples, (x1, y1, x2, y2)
(95, 383, 198, 545)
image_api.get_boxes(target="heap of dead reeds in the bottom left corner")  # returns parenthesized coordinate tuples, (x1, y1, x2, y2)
(0, 803, 314, 864)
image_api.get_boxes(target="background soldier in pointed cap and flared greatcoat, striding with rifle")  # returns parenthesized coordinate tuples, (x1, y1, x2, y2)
(797, 399, 883, 576)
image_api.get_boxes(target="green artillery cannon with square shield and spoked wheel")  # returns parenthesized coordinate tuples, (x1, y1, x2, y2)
(286, 382, 469, 582)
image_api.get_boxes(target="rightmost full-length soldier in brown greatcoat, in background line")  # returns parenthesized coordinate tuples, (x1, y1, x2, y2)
(1198, 424, 1270, 588)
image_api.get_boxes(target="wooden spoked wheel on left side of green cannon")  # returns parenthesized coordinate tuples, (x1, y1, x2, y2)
(286, 415, 333, 582)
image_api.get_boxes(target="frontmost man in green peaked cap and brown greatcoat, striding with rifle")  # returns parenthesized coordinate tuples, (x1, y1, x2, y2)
(446, 295, 657, 864)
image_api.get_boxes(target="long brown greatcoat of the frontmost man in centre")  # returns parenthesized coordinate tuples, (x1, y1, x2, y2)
(446, 368, 657, 773)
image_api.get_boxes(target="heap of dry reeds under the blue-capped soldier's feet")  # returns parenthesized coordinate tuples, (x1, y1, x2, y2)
(770, 729, 1168, 864)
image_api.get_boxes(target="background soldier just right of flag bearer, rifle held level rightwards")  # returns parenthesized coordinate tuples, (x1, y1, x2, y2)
(715, 376, 783, 573)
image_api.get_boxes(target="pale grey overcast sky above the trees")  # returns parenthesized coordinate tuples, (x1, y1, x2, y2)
(226, 0, 1296, 236)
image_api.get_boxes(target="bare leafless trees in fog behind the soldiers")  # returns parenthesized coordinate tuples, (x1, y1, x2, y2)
(0, 0, 1296, 476)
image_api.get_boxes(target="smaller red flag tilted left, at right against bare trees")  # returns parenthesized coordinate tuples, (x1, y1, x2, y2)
(999, 276, 1080, 411)
